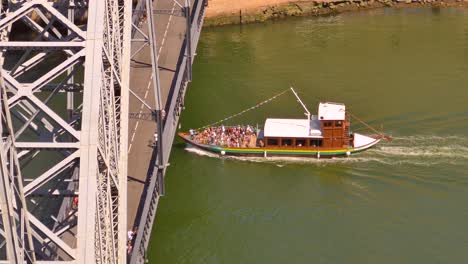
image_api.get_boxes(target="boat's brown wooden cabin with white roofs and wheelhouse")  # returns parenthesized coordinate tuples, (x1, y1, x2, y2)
(261, 103, 351, 149)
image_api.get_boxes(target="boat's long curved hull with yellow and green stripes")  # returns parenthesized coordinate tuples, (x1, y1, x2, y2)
(178, 133, 380, 158)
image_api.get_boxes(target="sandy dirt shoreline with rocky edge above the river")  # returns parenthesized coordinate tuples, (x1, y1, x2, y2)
(204, 0, 468, 27)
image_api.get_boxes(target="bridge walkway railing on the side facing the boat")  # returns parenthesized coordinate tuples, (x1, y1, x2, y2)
(129, 0, 208, 264)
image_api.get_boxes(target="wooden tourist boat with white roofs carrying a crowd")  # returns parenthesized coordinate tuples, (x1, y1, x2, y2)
(178, 88, 389, 158)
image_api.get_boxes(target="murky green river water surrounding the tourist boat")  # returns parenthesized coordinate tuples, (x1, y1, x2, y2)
(148, 8, 468, 263)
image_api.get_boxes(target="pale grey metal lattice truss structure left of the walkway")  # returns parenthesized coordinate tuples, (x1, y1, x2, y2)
(0, 0, 132, 263)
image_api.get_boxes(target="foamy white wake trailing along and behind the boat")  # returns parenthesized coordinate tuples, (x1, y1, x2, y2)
(186, 136, 468, 167)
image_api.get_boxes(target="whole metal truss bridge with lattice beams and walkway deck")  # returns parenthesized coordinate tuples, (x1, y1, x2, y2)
(0, 0, 207, 264)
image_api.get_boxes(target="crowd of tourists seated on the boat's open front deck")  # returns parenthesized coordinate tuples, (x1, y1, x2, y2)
(190, 125, 257, 148)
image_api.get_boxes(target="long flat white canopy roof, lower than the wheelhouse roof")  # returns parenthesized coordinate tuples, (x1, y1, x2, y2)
(263, 118, 322, 138)
